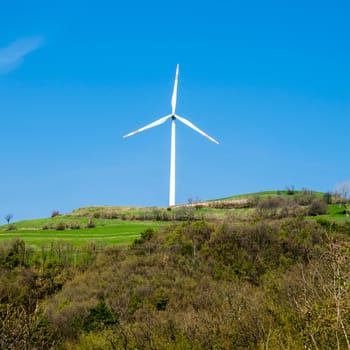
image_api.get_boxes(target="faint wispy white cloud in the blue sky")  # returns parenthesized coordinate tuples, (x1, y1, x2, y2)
(0, 37, 43, 74)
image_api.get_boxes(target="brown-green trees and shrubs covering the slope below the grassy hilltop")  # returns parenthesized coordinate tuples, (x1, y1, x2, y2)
(0, 198, 350, 350)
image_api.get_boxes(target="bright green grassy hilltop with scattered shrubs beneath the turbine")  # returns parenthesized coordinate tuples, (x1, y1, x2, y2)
(0, 190, 347, 248)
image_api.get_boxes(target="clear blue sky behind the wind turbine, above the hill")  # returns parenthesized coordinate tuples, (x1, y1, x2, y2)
(0, 0, 350, 222)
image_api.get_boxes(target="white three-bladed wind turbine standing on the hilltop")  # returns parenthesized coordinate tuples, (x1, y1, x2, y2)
(123, 64, 219, 206)
